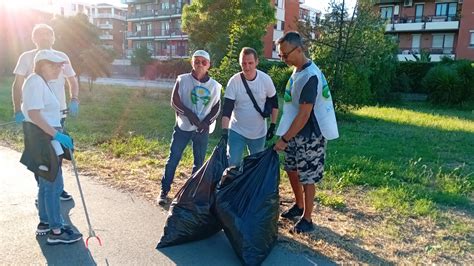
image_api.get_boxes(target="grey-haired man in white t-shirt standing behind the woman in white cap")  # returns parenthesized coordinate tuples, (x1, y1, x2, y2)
(12, 24, 79, 200)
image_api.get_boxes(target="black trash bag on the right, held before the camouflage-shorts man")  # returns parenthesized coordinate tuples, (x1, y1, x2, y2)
(215, 148, 280, 265)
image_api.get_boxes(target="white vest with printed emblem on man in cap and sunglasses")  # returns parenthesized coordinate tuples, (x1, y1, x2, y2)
(176, 73, 222, 133)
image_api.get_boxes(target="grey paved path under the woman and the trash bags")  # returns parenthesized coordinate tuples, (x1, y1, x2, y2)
(0, 146, 333, 266)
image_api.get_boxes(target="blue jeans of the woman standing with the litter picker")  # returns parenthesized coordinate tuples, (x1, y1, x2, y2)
(38, 163, 64, 229)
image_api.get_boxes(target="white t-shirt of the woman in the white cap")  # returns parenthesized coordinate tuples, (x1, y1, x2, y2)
(21, 74, 61, 127)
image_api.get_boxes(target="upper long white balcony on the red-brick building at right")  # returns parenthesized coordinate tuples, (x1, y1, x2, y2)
(385, 16, 459, 33)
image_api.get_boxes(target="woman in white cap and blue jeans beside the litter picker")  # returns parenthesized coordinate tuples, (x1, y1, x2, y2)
(21, 50, 82, 245)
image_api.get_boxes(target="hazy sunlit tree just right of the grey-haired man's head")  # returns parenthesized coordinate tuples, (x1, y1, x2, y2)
(51, 14, 114, 89)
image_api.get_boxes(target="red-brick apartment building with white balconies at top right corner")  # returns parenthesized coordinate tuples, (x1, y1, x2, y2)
(374, 0, 474, 61)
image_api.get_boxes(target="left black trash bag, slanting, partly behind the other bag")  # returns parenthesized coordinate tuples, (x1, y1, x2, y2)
(156, 139, 228, 248)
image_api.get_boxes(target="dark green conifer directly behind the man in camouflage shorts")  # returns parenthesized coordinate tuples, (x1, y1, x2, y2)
(310, 0, 397, 110)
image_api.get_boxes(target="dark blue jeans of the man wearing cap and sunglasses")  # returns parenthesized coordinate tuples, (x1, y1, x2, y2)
(161, 125, 209, 193)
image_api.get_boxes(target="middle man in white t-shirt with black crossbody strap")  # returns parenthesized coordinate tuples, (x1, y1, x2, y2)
(222, 47, 278, 166)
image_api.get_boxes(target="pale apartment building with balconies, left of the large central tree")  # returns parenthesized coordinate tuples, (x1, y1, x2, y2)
(122, 0, 191, 60)
